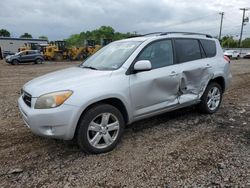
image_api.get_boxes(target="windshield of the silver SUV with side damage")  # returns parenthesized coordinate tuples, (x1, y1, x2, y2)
(80, 41, 141, 70)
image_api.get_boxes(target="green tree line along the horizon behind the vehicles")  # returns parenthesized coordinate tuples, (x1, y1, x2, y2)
(0, 26, 250, 48)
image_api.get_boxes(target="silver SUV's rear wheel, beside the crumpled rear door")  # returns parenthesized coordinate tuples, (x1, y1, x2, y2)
(199, 82, 222, 114)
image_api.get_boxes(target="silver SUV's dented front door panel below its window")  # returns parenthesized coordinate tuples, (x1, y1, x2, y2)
(130, 65, 180, 116)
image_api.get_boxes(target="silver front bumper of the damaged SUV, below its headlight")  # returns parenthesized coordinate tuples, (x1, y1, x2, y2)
(18, 97, 79, 140)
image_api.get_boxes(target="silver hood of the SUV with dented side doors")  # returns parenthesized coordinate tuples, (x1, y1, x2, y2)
(23, 67, 112, 97)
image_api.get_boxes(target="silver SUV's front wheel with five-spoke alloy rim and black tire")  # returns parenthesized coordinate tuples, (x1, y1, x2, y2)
(77, 104, 124, 154)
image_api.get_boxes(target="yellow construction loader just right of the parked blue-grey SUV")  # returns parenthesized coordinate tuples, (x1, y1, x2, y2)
(43, 41, 68, 61)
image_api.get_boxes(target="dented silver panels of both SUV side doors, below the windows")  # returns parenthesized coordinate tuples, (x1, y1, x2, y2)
(130, 59, 214, 117)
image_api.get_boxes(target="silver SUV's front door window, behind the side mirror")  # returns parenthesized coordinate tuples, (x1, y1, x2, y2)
(137, 40, 173, 69)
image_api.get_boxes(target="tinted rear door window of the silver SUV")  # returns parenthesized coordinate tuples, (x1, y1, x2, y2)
(175, 39, 202, 63)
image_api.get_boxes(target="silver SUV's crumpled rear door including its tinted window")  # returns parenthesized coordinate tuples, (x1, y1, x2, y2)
(174, 38, 213, 104)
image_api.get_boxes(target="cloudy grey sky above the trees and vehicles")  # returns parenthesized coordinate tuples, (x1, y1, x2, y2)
(0, 0, 250, 40)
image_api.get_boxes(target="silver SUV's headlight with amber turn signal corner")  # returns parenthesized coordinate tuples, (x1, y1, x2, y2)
(35, 90, 73, 109)
